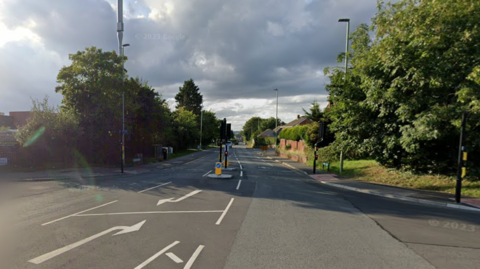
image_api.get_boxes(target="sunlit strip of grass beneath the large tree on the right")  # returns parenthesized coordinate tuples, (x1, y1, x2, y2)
(319, 160, 480, 197)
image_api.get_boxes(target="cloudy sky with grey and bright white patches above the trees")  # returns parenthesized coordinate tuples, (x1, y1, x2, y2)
(0, 0, 376, 130)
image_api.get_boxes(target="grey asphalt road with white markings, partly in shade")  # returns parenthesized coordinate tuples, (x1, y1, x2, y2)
(0, 146, 480, 269)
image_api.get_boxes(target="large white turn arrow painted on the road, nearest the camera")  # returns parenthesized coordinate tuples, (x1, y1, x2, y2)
(29, 220, 146, 264)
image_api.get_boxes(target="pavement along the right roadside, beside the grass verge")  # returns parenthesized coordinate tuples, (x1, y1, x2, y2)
(258, 150, 480, 213)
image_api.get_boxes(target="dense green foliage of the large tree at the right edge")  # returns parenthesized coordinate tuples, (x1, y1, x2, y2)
(326, 0, 480, 173)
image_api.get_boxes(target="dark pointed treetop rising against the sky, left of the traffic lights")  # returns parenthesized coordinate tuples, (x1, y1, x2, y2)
(175, 79, 203, 116)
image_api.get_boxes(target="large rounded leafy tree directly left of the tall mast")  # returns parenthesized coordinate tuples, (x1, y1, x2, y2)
(55, 47, 124, 163)
